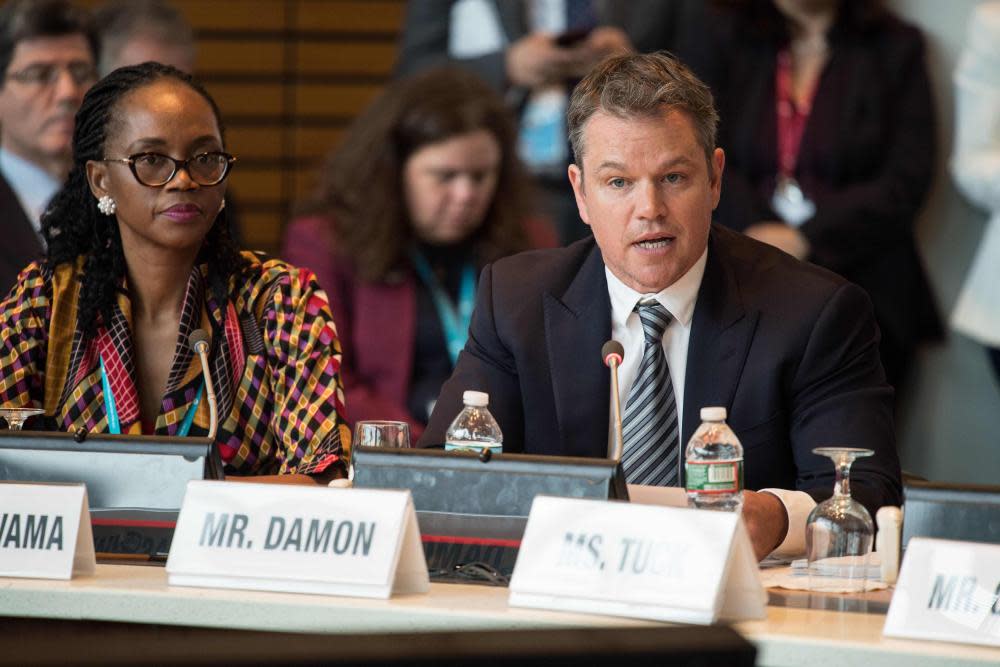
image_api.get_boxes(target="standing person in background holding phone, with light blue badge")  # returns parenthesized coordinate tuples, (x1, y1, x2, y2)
(396, 0, 702, 243)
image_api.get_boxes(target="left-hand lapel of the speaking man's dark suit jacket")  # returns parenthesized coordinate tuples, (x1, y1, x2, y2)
(543, 241, 611, 457)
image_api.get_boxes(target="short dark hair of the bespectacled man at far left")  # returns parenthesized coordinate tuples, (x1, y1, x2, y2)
(0, 0, 98, 77)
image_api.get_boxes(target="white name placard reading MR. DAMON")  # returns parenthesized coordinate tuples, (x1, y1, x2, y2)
(167, 481, 430, 598)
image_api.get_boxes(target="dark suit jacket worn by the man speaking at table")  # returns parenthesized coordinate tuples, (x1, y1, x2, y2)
(420, 226, 902, 516)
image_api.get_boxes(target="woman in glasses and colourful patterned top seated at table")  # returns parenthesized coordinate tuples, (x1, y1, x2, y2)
(0, 63, 350, 481)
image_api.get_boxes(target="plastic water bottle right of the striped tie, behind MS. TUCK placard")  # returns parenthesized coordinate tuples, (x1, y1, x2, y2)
(684, 408, 743, 512)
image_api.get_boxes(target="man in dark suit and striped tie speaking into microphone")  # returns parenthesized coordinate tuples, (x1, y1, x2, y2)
(420, 54, 901, 557)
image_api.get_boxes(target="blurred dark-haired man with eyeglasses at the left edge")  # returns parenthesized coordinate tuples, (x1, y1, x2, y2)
(0, 0, 98, 294)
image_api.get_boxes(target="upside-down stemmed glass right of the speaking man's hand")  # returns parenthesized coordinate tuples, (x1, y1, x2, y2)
(806, 447, 875, 592)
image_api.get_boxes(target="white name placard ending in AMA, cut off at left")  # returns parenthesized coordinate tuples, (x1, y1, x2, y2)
(0, 482, 96, 579)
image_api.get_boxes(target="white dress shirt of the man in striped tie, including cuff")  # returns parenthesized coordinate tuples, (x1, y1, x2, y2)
(604, 249, 816, 557)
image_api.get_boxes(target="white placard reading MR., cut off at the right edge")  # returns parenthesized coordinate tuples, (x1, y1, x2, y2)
(882, 537, 1000, 646)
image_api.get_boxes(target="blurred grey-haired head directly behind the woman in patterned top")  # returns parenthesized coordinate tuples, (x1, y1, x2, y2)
(94, 0, 197, 76)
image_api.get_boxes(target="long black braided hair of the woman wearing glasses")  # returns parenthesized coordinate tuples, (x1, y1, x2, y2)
(42, 62, 247, 338)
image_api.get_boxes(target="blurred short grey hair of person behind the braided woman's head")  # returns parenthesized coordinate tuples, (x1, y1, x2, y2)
(94, 0, 195, 74)
